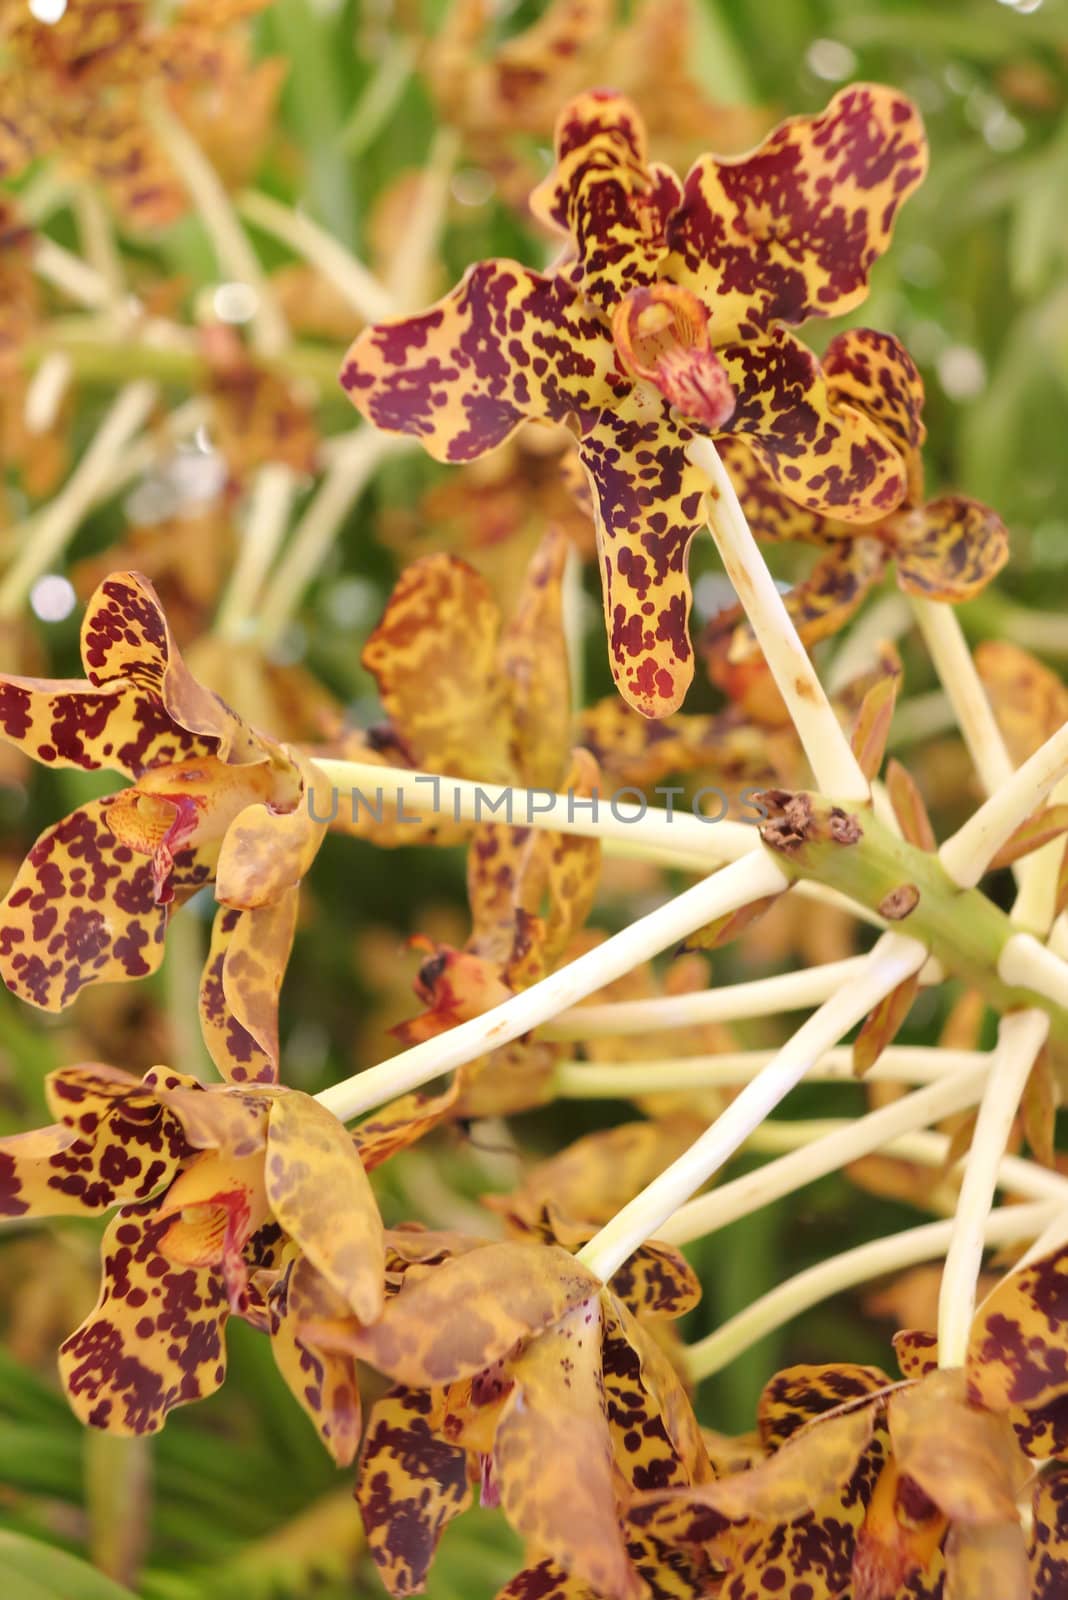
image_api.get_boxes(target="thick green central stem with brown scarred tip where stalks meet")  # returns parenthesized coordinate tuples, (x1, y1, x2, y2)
(761, 790, 1068, 1042)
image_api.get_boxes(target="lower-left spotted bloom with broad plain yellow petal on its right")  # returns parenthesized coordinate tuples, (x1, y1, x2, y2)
(0, 1066, 385, 1461)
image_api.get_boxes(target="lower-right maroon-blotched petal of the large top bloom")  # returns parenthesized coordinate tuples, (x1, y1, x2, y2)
(718, 328, 908, 523)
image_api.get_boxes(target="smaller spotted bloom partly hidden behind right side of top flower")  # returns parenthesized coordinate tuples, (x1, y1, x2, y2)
(721, 328, 1009, 653)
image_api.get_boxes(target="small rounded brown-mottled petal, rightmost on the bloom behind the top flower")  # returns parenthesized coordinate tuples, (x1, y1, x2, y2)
(889, 494, 1009, 605)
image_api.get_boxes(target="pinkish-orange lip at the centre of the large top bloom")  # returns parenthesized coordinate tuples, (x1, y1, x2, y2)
(612, 283, 737, 429)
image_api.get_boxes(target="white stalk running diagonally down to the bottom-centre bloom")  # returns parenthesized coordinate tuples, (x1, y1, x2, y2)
(579, 933, 927, 1282)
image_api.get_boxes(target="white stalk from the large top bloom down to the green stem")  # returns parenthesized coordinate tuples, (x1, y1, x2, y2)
(689, 438, 868, 802)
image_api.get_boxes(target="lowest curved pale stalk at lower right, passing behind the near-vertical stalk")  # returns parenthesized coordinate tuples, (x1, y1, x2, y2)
(686, 1198, 1065, 1382)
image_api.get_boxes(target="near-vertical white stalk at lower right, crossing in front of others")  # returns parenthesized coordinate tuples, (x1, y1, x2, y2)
(938, 1011, 1049, 1366)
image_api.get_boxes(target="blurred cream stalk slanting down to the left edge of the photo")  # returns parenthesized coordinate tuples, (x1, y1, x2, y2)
(0, 378, 157, 618)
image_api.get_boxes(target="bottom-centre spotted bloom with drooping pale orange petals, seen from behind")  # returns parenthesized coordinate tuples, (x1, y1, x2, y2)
(317, 1234, 708, 1600)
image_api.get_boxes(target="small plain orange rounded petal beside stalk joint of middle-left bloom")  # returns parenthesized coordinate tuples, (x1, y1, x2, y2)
(216, 762, 326, 910)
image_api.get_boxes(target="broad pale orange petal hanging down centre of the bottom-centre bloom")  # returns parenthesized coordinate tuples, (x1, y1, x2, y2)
(494, 1294, 643, 1600)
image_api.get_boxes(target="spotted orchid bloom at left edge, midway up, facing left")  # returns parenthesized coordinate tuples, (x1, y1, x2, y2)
(0, 573, 325, 1080)
